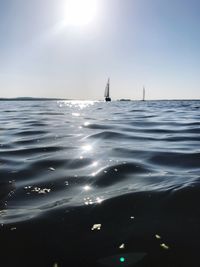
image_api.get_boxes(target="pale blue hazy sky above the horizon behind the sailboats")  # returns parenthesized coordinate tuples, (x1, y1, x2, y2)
(0, 0, 200, 100)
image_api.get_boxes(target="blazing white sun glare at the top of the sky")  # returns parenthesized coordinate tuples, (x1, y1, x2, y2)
(65, 0, 98, 26)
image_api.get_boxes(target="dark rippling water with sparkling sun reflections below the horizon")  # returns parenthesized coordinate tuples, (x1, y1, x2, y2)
(0, 101, 200, 267)
